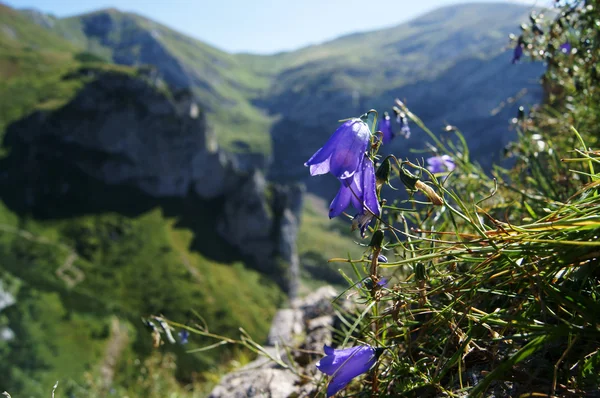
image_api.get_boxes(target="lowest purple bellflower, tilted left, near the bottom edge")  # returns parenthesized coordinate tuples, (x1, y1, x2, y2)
(317, 345, 383, 397)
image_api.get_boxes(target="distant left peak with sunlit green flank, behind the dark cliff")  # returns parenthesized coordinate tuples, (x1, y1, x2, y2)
(26, 9, 271, 159)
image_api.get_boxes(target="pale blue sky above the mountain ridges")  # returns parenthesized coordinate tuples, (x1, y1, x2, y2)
(7, 0, 549, 54)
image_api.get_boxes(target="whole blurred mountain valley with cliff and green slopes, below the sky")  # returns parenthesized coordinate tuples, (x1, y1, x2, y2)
(0, 3, 542, 396)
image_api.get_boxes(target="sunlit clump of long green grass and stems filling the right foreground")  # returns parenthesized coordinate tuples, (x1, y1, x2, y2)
(163, 1, 600, 397)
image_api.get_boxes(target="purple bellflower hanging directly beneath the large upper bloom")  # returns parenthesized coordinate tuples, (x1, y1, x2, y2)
(329, 155, 381, 237)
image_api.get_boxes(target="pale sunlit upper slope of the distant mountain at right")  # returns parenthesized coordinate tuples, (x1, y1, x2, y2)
(268, 3, 529, 88)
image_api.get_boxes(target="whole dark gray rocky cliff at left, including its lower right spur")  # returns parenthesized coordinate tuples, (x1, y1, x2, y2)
(5, 67, 302, 293)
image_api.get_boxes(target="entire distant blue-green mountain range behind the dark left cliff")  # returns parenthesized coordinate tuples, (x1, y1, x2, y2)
(21, 3, 542, 176)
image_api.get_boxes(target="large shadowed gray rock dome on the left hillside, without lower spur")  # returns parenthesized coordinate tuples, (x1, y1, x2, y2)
(9, 69, 240, 199)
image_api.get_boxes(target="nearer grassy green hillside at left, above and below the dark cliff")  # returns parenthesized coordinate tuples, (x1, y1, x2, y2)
(0, 6, 282, 396)
